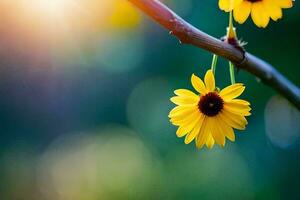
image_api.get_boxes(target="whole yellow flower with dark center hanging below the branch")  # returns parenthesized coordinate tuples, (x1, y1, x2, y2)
(169, 70, 251, 149)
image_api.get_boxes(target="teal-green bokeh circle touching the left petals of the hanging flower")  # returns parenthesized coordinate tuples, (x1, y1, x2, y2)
(127, 77, 176, 147)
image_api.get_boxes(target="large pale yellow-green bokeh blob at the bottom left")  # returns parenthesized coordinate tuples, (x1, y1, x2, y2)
(39, 125, 159, 200)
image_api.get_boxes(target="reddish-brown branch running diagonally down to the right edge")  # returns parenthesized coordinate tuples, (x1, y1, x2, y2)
(129, 0, 300, 110)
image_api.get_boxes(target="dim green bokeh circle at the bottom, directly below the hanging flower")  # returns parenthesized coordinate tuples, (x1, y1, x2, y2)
(166, 149, 254, 200)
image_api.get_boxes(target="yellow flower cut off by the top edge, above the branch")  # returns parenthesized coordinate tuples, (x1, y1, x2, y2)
(219, 0, 293, 28)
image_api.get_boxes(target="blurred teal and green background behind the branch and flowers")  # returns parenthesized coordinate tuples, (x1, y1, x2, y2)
(0, 0, 300, 200)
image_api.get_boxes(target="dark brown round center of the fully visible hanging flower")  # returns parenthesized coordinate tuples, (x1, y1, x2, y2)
(198, 92, 224, 117)
